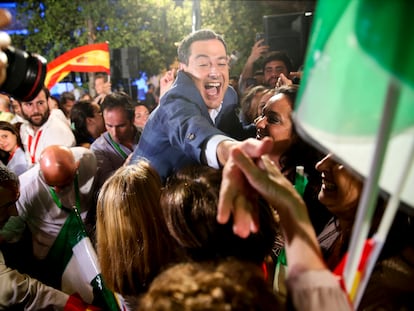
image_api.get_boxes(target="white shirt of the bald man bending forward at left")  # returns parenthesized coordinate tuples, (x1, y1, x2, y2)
(1, 147, 96, 259)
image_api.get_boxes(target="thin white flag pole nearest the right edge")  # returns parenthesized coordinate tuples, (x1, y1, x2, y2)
(354, 137, 414, 309)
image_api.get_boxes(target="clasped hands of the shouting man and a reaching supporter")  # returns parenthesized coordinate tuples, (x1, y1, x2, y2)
(217, 138, 305, 238)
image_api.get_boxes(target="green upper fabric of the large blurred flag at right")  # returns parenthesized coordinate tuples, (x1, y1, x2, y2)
(297, 0, 414, 139)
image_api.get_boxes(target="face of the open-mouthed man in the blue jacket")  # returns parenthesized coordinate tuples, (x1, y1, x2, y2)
(182, 39, 229, 109)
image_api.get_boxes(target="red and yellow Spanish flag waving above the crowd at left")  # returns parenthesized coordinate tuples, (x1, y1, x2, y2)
(45, 42, 110, 89)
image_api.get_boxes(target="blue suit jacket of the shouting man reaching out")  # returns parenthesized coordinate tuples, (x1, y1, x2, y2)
(131, 72, 252, 181)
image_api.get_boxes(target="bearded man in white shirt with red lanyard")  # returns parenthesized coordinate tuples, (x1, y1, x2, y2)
(20, 88, 76, 165)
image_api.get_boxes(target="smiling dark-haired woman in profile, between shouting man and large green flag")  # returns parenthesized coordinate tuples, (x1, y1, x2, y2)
(255, 84, 331, 233)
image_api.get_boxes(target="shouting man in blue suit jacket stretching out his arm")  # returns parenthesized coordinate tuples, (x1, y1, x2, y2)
(131, 29, 254, 180)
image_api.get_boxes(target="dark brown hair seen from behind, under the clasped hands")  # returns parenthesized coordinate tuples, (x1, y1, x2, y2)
(161, 165, 278, 265)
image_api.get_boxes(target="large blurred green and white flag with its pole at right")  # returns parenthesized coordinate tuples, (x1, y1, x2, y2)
(294, 0, 414, 308)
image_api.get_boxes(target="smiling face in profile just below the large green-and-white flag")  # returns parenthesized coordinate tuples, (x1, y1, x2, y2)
(316, 154, 363, 214)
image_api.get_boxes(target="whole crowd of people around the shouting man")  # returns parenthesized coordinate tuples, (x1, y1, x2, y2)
(0, 7, 414, 310)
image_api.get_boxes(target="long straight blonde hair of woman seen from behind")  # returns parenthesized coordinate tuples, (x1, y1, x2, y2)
(96, 161, 172, 295)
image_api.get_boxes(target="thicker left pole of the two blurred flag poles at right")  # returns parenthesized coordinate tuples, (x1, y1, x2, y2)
(344, 77, 400, 301)
